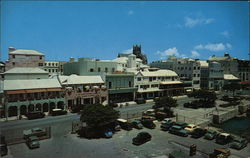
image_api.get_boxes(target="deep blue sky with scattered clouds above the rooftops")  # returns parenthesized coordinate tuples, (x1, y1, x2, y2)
(1, 1, 250, 62)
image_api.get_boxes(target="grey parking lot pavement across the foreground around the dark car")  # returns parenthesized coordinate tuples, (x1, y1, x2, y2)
(5, 122, 250, 158)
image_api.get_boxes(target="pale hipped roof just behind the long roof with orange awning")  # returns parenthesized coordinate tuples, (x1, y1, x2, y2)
(4, 67, 48, 74)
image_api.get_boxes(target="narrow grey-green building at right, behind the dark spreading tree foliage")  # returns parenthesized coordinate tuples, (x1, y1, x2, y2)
(208, 61, 224, 91)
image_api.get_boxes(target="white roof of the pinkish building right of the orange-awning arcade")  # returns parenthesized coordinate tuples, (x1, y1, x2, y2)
(59, 75, 104, 85)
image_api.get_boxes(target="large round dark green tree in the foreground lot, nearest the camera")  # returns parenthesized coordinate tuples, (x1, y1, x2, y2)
(80, 104, 120, 127)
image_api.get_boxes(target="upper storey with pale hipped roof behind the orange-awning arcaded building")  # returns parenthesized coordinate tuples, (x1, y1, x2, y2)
(4, 67, 49, 80)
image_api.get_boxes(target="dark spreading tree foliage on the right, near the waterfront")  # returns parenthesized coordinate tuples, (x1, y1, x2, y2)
(188, 89, 217, 102)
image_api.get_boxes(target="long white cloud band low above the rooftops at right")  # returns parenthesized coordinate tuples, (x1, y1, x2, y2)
(194, 43, 232, 52)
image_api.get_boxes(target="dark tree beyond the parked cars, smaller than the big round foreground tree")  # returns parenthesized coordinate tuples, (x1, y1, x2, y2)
(154, 96, 177, 111)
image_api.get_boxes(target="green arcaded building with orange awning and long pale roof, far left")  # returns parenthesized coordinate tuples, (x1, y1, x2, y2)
(3, 79, 64, 118)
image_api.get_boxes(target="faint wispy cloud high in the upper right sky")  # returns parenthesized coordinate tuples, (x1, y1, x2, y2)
(185, 17, 214, 28)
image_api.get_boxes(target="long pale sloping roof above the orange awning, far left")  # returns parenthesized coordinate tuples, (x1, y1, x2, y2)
(4, 79, 61, 91)
